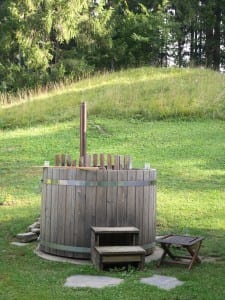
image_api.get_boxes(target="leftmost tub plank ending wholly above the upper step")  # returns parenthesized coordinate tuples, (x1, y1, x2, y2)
(96, 170, 107, 226)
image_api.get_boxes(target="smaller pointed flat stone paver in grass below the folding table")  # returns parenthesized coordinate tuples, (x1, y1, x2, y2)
(141, 275, 184, 291)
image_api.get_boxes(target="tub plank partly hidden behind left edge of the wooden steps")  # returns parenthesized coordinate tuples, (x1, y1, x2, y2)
(84, 171, 97, 248)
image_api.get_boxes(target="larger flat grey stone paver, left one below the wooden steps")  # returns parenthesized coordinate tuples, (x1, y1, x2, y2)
(64, 275, 123, 289)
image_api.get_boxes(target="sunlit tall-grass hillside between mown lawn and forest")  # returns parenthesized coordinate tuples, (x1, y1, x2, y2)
(0, 67, 225, 129)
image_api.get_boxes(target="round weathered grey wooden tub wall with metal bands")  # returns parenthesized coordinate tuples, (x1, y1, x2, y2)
(40, 167, 156, 259)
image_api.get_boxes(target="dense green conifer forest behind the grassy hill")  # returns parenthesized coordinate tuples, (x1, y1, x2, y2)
(0, 0, 225, 92)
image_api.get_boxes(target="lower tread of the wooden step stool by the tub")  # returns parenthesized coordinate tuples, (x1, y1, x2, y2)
(95, 246, 145, 255)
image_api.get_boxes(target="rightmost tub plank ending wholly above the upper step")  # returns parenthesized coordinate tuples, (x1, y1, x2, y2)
(127, 170, 137, 226)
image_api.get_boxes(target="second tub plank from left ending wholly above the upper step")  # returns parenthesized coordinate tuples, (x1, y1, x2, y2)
(106, 170, 118, 226)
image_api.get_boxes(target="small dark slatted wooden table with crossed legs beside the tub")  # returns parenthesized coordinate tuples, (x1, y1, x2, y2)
(156, 234, 204, 270)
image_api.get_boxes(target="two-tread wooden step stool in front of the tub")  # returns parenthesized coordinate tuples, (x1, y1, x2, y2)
(91, 227, 145, 270)
